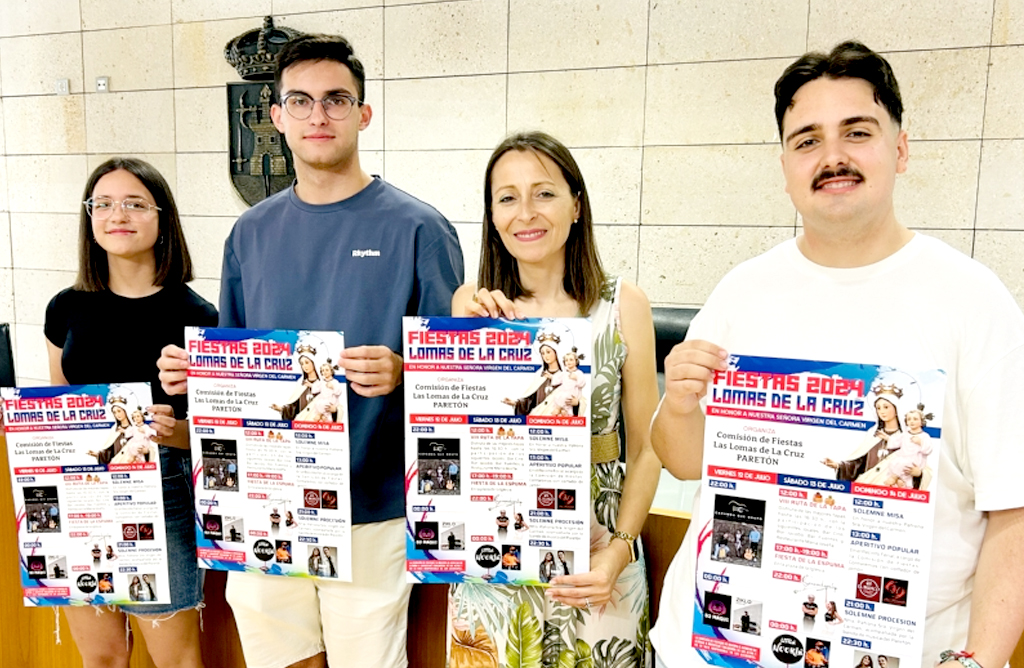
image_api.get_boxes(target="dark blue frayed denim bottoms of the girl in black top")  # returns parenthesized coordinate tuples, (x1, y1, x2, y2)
(120, 446, 203, 617)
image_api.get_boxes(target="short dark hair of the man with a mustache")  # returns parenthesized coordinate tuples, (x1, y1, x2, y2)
(775, 41, 903, 138)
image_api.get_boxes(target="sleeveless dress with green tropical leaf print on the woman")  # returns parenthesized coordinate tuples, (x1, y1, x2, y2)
(447, 278, 651, 668)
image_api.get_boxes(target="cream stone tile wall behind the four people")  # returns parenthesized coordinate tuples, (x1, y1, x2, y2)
(0, 0, 1024, 382)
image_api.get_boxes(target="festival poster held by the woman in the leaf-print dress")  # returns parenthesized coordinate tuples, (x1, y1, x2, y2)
(403, 318, 593, 584)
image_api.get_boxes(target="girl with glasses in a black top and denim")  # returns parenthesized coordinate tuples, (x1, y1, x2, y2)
(44, 158, 217, 668)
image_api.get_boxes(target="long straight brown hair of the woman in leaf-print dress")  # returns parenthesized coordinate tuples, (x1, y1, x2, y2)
(477, 132, 605, 316)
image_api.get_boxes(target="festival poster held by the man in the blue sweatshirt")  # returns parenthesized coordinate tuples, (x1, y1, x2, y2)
(185, 327, 352, 582)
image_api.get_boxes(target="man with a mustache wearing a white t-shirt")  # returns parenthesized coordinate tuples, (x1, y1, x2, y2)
(651, 42, 1024, 668)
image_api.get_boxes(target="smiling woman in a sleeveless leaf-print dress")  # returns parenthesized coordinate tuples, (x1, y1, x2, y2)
(447, 132, 660, 668)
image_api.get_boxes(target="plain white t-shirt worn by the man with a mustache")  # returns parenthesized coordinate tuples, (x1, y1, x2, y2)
(651, 235, 1024, 668)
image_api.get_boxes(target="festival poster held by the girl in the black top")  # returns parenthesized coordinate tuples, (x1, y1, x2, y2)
(0, 383, 170, 607)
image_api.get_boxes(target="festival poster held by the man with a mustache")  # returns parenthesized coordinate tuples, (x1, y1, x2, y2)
(692, 356, 946, 668)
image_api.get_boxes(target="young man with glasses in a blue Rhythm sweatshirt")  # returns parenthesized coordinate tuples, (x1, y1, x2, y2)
(160, 35, 463, 668)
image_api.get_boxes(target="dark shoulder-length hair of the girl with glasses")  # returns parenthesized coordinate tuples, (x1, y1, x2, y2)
(75, 157, 193, 292)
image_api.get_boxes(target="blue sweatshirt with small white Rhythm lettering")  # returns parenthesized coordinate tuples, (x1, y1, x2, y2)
(220, 177, 463, 524)
